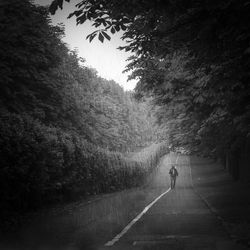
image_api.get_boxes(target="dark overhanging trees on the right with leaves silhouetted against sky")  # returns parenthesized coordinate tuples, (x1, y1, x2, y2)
(50, 0, 250, 178)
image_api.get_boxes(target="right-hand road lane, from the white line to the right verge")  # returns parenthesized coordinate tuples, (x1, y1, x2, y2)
(99, 154, 246, 250)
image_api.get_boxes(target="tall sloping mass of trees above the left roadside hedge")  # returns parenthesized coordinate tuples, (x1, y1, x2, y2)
(0, 1, 157, 151)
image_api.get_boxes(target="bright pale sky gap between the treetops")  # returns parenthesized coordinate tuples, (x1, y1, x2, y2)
(34, 0, 136, 90)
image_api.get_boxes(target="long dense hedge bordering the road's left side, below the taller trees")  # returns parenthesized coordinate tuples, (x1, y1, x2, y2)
(0, 114, 166, 217)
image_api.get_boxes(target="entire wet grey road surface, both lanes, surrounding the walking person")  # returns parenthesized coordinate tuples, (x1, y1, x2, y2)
(1, 154, 245, 250)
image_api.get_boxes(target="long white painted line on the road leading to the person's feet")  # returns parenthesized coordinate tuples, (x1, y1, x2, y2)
(104, 188, 171, 247)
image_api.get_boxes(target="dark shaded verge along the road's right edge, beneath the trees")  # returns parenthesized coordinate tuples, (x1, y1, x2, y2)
(190, 157, 250, 248)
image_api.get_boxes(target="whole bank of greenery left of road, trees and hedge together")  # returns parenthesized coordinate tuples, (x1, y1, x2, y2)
(0, 0, 168, 227)
